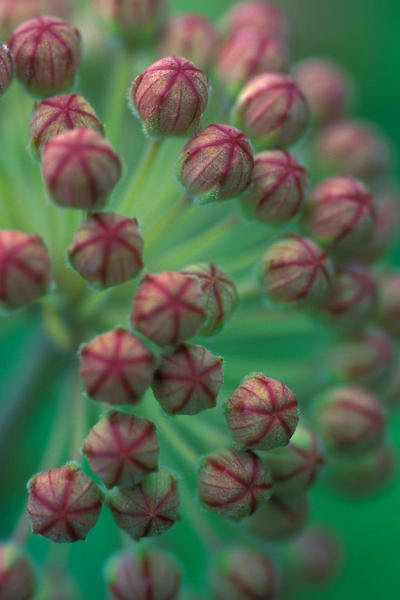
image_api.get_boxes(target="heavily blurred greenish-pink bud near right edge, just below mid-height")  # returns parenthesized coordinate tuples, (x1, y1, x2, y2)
(330, 328, 396, 387)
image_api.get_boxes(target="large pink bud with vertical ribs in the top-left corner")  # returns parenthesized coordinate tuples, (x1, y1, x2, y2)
(8, 16, 82, 97)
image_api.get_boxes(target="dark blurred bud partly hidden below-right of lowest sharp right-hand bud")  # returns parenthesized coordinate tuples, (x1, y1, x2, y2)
(246, 495, 310, 541)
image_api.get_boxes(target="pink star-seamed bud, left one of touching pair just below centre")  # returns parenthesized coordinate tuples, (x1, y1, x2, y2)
(79, 327, 154, 404)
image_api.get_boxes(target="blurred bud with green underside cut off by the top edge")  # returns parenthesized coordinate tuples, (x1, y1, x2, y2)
(94, 0, 165, 46)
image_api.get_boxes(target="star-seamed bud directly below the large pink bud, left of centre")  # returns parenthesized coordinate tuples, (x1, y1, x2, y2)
(68, 213, 144, 288)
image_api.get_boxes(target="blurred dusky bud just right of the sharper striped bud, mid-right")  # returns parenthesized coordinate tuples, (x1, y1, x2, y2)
(323, 264, 378, 327)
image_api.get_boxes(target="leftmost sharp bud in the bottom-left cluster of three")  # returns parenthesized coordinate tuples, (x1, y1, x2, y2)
(28, 463, 103, 543)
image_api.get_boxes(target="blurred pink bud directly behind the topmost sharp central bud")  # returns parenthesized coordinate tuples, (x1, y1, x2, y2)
(158, 13, 219, 70)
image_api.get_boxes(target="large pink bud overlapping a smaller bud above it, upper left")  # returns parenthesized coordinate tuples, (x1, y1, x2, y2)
(42, 128, 121, 210)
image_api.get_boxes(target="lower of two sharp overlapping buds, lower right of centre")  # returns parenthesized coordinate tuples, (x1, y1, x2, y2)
(199, 448, 272, 521)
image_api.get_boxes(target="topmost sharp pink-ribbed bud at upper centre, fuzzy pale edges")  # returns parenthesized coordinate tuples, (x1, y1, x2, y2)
(130, 56, 210, 138)
